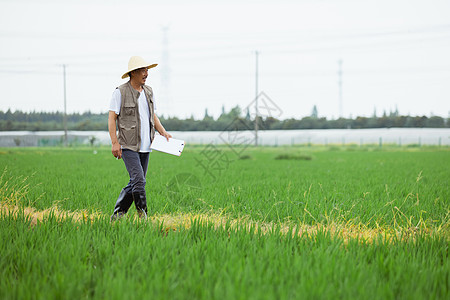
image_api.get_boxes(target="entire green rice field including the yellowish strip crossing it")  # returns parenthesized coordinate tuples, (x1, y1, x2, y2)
(0, 145, 450, 299)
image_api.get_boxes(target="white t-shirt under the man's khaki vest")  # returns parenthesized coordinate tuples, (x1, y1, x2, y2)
(109, 89, 156, 152)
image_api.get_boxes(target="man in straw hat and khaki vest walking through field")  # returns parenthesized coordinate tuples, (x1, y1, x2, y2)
(108, 56, 172, 221)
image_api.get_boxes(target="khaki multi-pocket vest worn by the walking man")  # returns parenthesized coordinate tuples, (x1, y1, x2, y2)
(117, 81, 155, 152)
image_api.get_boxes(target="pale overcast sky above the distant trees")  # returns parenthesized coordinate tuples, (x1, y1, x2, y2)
(0, 0, 450, 119)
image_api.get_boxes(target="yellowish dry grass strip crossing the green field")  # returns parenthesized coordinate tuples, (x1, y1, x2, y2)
(0, 203, 442, 242)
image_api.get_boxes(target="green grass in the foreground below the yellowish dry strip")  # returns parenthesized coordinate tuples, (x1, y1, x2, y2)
(0, 217, 449, 299)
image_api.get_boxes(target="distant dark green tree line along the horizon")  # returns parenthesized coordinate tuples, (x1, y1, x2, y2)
(0, 106, 450, 131)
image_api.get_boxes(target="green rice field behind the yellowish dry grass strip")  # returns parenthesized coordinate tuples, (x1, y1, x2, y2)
(0, 147, 450, 226)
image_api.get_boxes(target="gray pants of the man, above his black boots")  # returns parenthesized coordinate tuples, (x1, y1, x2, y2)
(122, 149, 149, 194)
